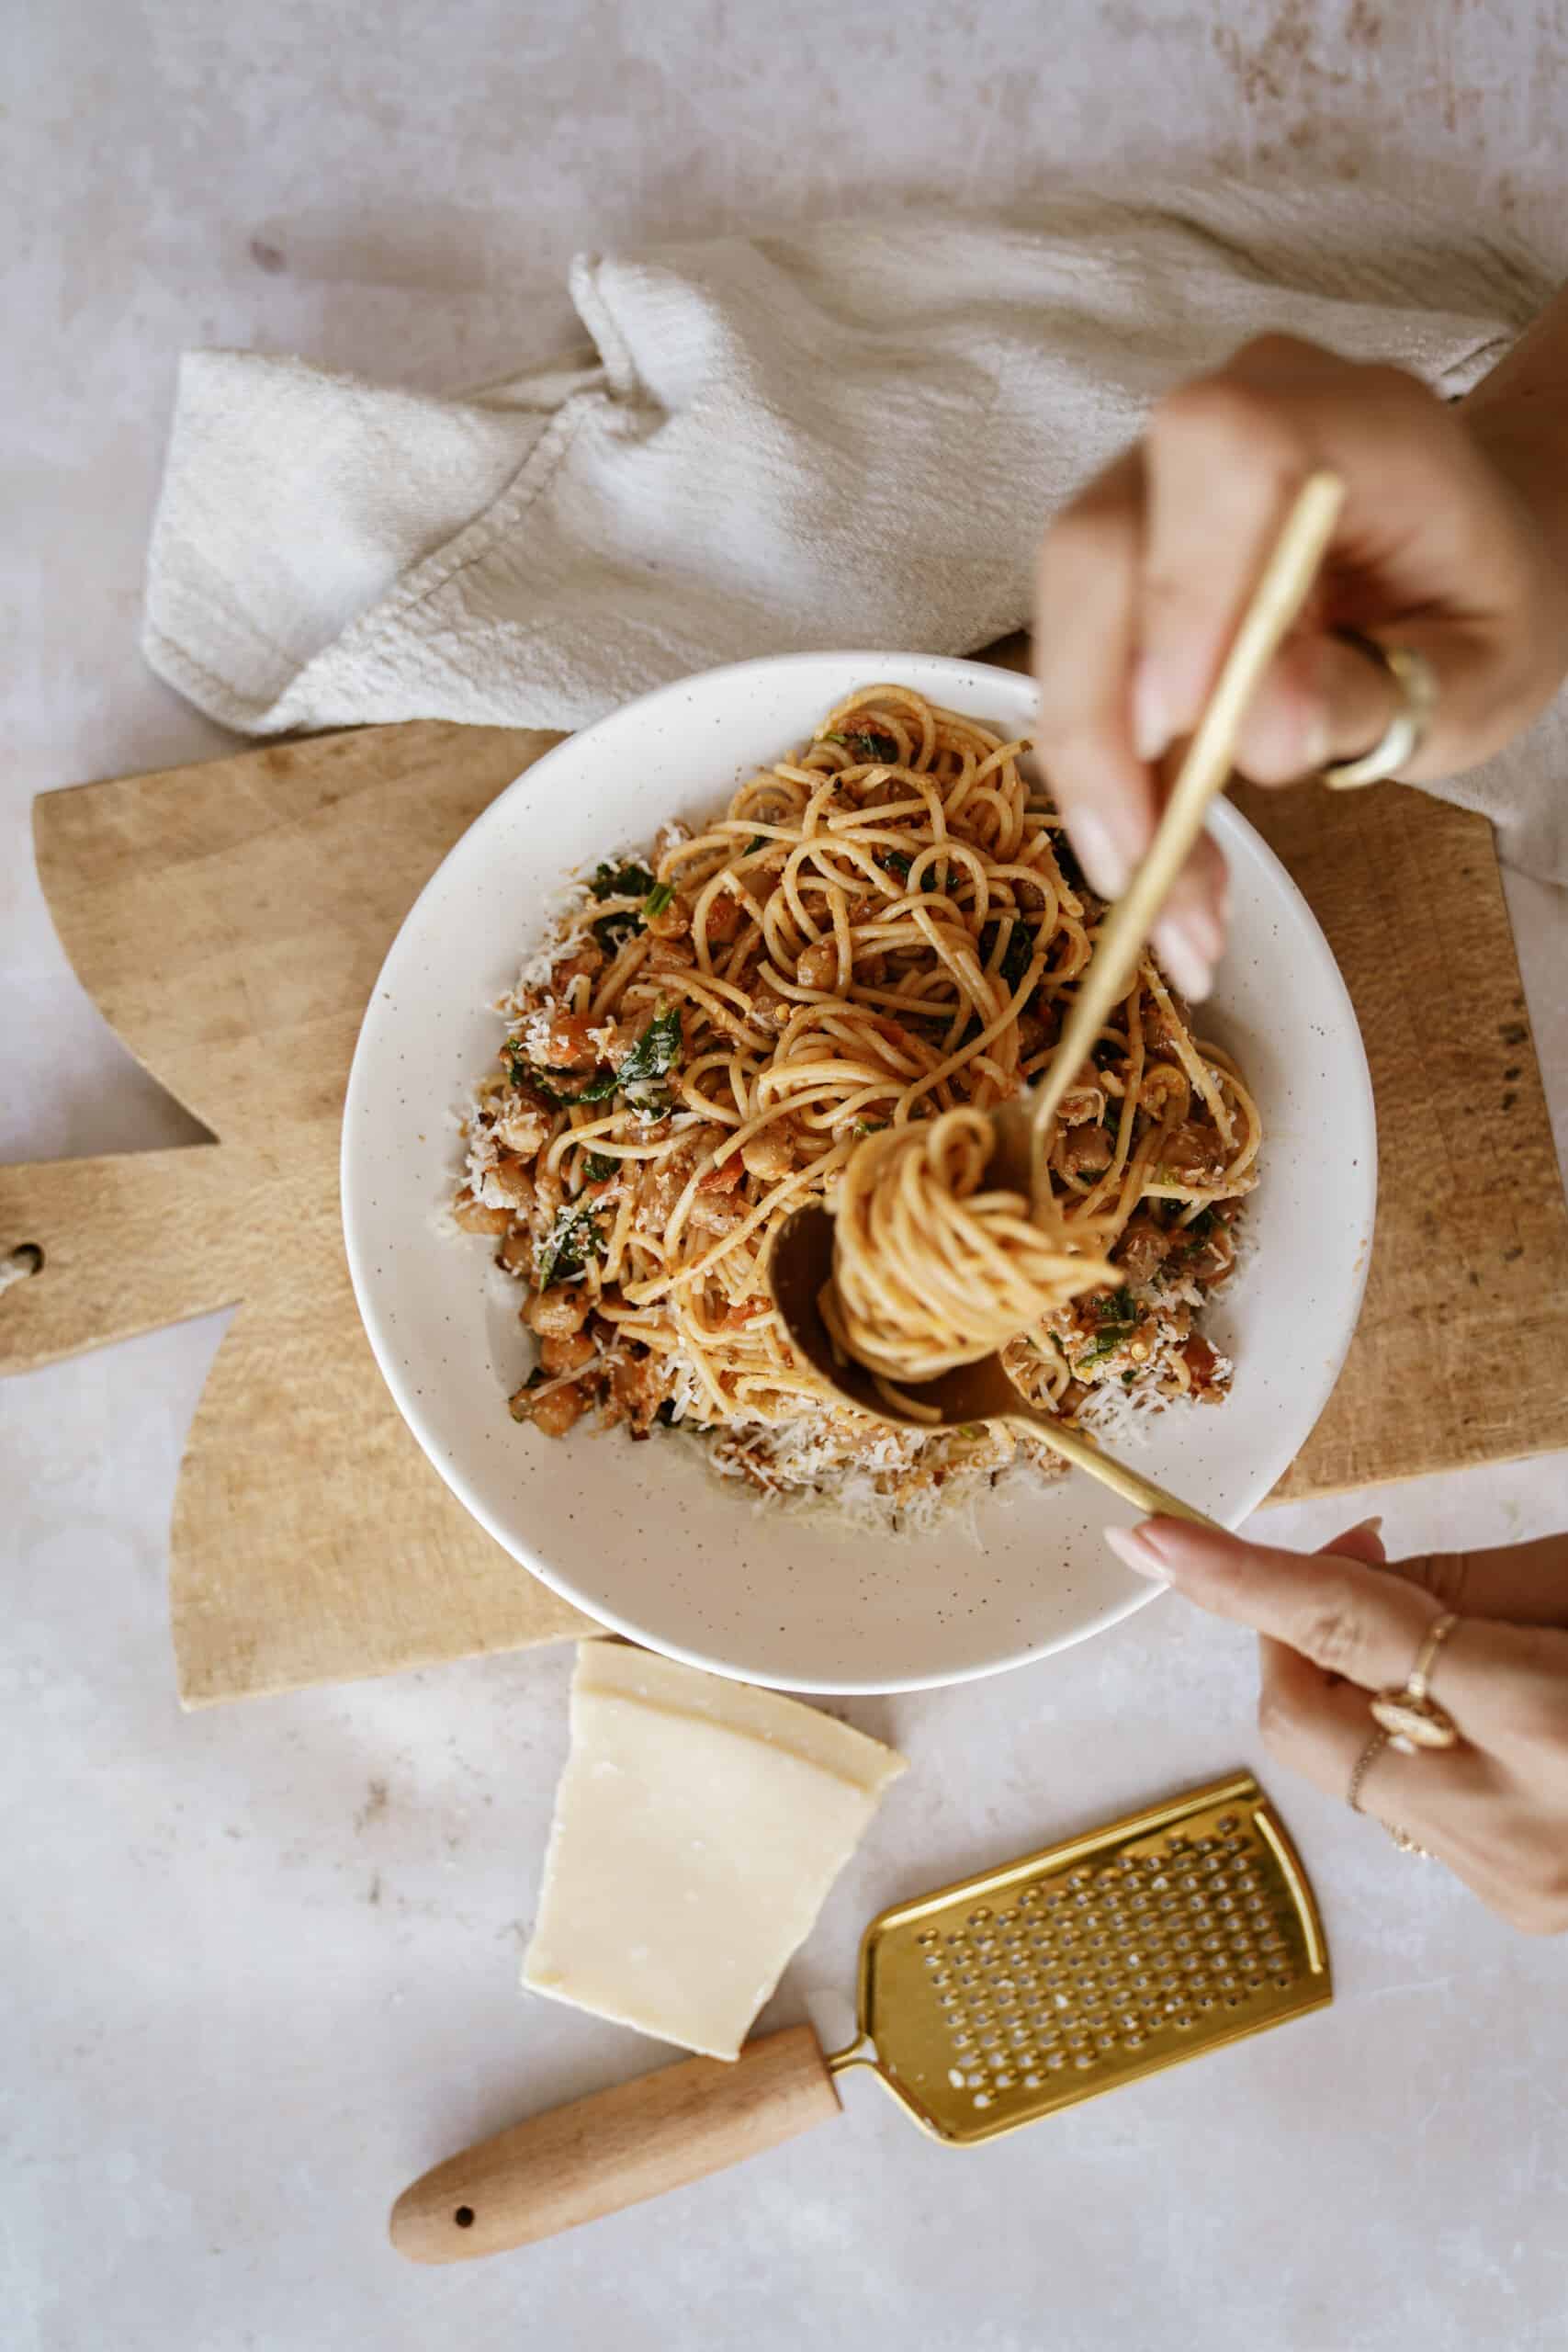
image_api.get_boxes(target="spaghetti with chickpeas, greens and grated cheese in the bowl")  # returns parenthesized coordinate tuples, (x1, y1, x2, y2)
(454, 684, 1260, 1510)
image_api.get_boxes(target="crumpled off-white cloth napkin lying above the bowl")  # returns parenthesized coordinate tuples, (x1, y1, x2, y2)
(143, 186, 1568, 879)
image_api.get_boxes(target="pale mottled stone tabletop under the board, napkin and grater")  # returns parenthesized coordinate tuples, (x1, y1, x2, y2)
(0, 0, 1568, 2352)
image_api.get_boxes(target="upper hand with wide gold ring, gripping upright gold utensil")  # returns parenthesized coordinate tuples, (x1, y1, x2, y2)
(1034, 324, 1568, 997)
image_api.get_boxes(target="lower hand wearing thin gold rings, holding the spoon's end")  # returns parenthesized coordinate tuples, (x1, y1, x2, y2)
(1107, 1520, 1568, 1936)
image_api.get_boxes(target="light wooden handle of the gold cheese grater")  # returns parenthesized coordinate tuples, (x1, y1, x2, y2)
(390, 2025, 840, 2263)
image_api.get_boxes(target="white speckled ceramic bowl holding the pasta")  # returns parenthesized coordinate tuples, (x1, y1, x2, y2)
(344, 654, 1375, 1691)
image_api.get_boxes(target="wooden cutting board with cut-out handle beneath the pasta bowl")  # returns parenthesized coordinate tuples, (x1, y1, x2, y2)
(0, 722, 1568, 1705)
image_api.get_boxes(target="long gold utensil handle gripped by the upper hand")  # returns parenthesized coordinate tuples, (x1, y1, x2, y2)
(1030, 473, 1345, 1200)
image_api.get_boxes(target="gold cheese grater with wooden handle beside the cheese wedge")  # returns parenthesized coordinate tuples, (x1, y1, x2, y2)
(392, 1773, 1333, 2263)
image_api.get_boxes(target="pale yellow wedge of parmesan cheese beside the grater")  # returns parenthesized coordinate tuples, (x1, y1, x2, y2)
(522, 1642, 905, 2058)
